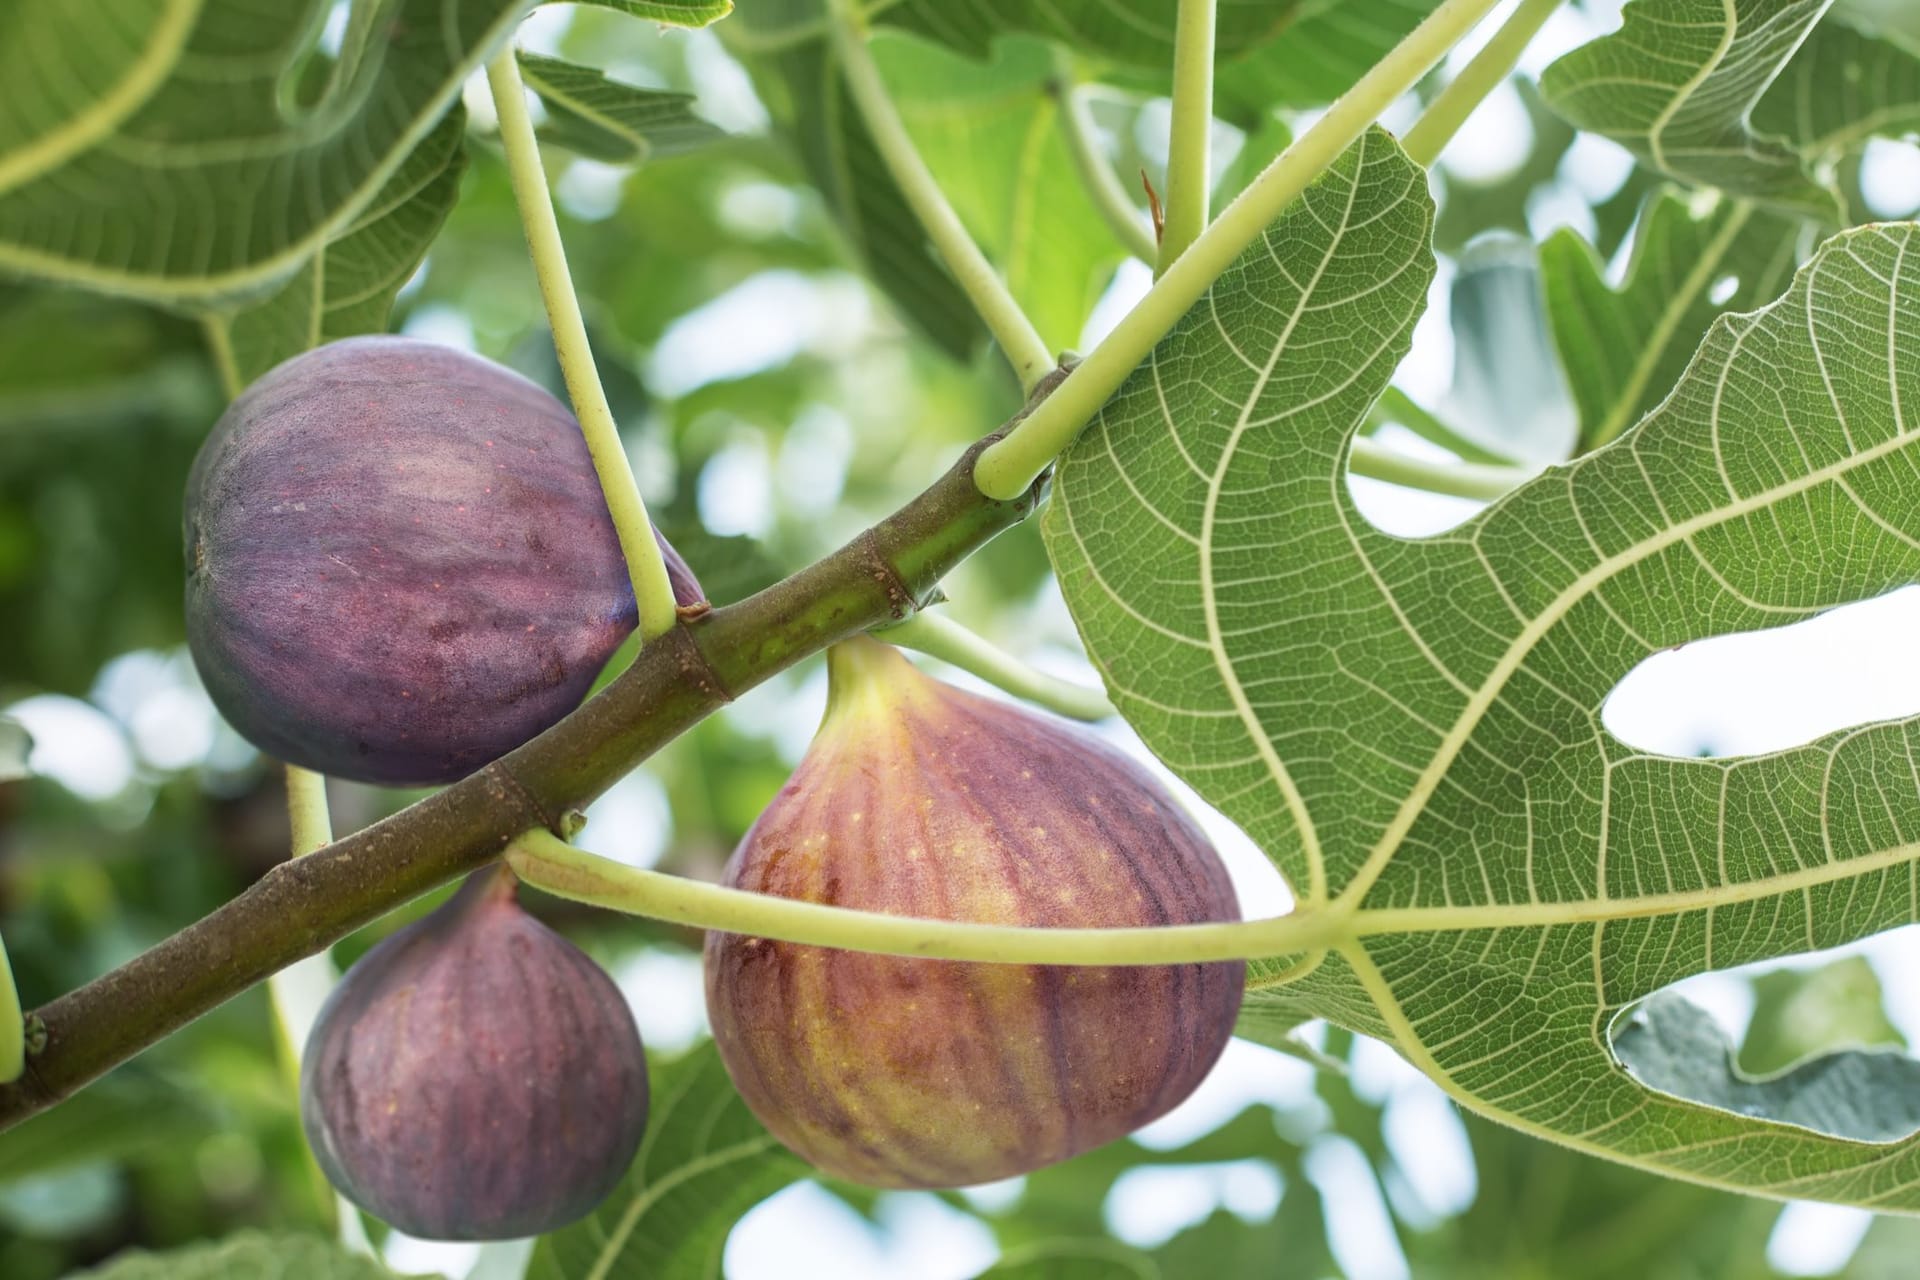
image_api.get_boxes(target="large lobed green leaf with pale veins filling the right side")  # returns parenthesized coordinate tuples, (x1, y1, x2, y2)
(1044, 117, 1920, 1209)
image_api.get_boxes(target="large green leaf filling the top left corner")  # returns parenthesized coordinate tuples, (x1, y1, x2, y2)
(0, 0, 530, 307)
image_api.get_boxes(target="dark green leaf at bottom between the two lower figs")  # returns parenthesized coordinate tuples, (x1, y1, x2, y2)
(526, 1042, 806, 1280)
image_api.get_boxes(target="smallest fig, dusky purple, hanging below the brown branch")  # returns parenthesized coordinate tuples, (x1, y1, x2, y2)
(300, 867, 647, 1240)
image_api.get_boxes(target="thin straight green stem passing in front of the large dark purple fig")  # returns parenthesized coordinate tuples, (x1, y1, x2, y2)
(486, 44, 676, 641)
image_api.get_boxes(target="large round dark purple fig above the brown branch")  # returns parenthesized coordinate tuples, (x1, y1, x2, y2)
(184, 336, 701, 785)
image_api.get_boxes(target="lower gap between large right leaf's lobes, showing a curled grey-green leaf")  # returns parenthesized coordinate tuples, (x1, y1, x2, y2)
(1609, 927, 1920, 1142)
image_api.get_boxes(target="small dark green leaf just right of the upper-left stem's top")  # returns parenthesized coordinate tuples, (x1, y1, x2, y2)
(520, 54, 726, 165)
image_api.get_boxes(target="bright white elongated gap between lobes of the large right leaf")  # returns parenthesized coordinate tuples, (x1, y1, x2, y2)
(1601, 587, 1920, 756)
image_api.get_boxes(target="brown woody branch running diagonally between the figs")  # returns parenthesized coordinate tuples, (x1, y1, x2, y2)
(0, 372, 1064, 1128)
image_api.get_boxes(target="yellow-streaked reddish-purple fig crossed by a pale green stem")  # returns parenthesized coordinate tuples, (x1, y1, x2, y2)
(707, 637, 1244, 1188)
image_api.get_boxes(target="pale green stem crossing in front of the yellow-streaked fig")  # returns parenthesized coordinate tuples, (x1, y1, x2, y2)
(507, 829, 1352, 965)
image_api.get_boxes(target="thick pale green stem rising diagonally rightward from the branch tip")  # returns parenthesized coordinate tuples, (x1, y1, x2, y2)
(973, 0, 1500, 497)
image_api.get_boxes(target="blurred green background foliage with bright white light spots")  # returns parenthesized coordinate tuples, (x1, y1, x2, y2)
(0, 0, 1920, 1280)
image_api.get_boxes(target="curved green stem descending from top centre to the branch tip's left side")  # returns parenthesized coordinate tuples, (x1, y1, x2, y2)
(828, 0, 1054, 393)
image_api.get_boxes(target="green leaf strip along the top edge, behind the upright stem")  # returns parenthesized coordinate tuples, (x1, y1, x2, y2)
(877, 0, 1300, 71)
